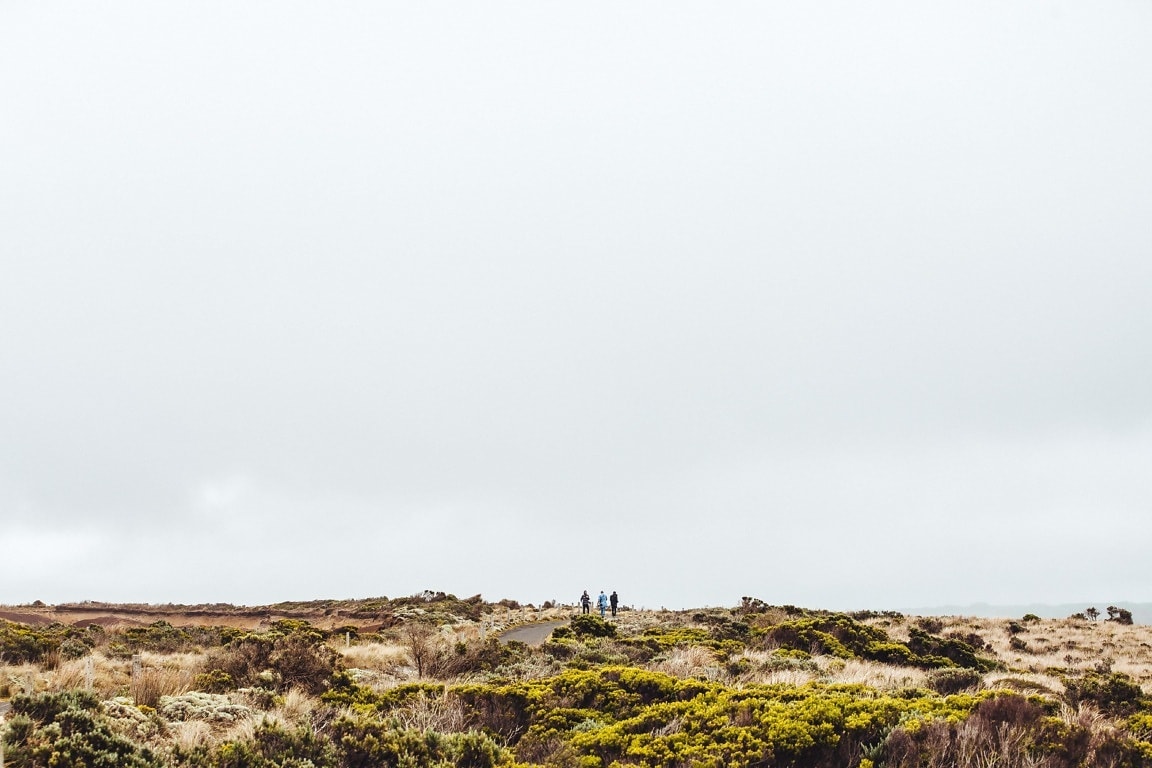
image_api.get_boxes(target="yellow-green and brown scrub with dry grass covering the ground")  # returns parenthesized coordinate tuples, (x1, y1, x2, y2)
(0, 593, 1152, 768)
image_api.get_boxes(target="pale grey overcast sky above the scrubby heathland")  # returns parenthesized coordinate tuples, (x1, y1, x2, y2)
(0, 0, 1152, 609)
